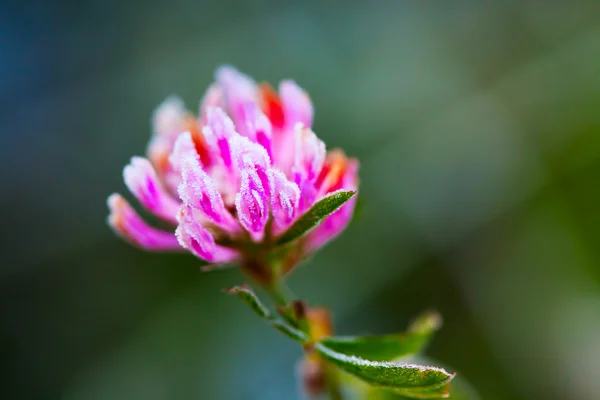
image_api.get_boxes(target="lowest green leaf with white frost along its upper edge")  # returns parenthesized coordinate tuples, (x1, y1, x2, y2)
(315, 342, 454, 398)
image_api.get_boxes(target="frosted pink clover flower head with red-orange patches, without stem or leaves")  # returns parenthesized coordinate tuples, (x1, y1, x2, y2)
(109, 67, 358, 276)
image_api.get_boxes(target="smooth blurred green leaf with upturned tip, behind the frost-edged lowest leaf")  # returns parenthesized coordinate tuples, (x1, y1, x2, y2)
(321, 312, 441, 361)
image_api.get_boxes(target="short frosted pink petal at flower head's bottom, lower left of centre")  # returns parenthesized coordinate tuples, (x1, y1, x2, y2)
(175, 206, 238, 263)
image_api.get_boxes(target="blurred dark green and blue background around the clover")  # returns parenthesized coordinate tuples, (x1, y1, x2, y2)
(0, 0, 600, 400)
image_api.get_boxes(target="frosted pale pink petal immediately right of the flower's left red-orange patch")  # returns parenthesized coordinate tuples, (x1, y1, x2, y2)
(202, 107, 238, 169)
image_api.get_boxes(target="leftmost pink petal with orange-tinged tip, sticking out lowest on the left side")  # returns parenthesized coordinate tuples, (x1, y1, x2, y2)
(107, 193, 181, 251)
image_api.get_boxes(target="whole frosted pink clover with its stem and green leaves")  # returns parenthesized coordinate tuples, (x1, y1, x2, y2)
(108, 67, 454, 399)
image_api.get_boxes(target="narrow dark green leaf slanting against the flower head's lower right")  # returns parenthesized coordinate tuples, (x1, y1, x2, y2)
(275, 190, 356, 246)
